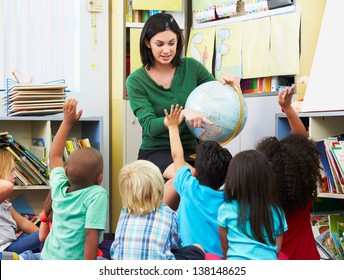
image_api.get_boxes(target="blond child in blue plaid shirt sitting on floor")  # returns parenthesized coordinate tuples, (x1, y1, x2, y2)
(110, 160, 204, 260)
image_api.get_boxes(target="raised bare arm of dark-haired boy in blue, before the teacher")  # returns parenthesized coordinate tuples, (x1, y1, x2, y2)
(164, 104, 186, 172)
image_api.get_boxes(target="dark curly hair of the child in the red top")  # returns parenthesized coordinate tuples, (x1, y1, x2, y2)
(257, 134, 321, 213)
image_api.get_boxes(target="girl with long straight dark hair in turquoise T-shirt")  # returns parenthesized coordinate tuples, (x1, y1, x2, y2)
(217, 150, 287, 260)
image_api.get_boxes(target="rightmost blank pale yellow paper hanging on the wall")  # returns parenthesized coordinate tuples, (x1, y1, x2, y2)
(270, 12, 300, 76)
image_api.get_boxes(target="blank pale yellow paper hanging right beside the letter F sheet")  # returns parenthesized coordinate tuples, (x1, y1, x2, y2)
(241, 17, 271, 79)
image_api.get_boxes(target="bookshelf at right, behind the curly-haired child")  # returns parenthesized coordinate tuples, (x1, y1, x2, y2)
(275, 111, 344, 202)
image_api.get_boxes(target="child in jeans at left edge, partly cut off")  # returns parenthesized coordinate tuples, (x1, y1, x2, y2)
(0, 149, 40, 258)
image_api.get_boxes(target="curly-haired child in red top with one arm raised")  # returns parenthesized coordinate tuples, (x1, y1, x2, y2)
(256, 84, 321, 260)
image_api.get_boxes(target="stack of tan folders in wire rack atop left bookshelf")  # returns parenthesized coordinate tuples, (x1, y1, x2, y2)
(3, 84, 67, 116)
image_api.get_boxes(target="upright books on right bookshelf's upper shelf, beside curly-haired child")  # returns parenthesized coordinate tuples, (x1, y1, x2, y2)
(316, 134, 344, 194)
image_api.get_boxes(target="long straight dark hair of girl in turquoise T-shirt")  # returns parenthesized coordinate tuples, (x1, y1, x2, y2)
(225, 150, 283, 244)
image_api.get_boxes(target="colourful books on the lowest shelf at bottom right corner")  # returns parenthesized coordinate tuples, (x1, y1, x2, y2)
(311, 211, 344, 260)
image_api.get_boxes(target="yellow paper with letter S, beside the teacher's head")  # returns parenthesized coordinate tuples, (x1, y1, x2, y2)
(186, 28, 215, 73)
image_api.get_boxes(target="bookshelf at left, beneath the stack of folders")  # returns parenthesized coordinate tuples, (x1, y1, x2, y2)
(0, 114, 103, 214)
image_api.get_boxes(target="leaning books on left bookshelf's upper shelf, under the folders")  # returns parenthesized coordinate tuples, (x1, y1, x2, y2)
(0, 131, 49, 186)
